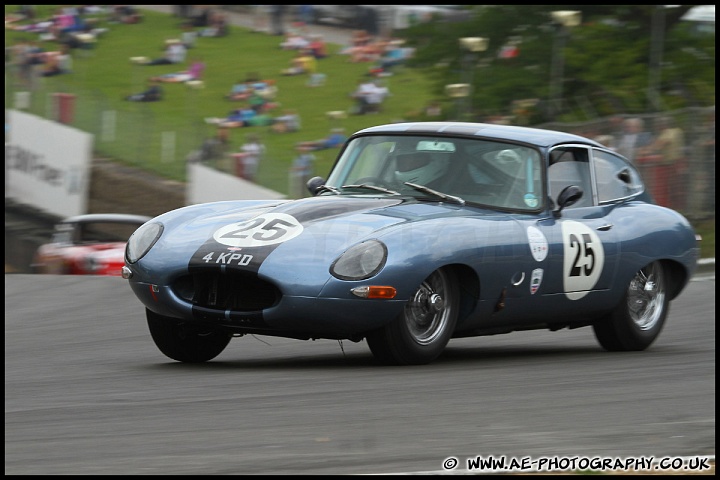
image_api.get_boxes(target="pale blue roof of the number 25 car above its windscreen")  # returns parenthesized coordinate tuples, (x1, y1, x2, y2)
(355, 122, 602, 147)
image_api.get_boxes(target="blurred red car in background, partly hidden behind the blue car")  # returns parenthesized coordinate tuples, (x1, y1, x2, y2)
(32, 213, 151, 277)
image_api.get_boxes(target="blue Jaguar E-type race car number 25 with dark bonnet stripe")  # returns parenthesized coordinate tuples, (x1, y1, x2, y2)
(123, 122, 698, 364)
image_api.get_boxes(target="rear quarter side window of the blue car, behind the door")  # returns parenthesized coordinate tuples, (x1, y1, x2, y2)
(593, 150, 644, 203)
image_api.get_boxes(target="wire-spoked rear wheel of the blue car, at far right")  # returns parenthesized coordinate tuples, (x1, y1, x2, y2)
(593, 262, 669, 351)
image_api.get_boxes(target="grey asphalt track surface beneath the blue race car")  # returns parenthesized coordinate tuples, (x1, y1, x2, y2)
(5, 274, 715, 475)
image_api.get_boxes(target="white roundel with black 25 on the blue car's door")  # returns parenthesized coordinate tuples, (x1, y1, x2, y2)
(562, 221, 605, 300)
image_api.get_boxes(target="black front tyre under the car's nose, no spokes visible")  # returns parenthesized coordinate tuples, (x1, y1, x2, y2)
(146, 309, 232, 363)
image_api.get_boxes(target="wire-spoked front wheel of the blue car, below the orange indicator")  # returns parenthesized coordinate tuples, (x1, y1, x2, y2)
(366, 270, 460, 365)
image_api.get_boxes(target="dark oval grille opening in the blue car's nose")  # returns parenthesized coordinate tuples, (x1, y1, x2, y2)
(172, 272, 281, 312)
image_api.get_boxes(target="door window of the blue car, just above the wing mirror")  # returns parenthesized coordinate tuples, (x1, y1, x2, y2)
(548, 147, 593, 208)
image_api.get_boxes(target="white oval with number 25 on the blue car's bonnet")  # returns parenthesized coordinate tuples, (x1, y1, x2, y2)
(213, 213, 303, 247)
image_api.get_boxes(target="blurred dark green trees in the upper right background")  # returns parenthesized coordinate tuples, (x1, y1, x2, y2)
(403, 5, 715, 121)
